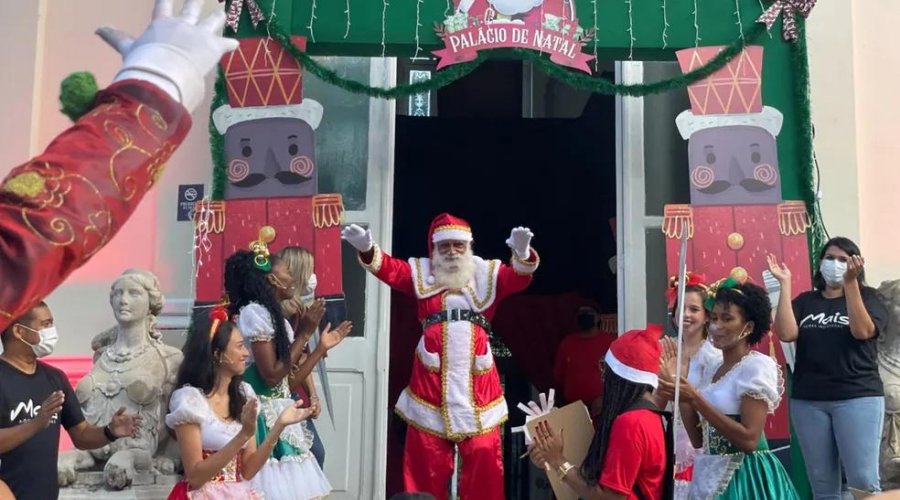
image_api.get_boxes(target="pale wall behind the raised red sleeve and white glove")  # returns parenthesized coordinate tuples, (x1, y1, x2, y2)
(0, 0, 221, 354)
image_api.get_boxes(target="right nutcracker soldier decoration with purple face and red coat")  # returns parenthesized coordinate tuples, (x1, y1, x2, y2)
(663, 46, 811, 465)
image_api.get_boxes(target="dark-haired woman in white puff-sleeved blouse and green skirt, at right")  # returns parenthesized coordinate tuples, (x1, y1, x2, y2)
(660, 278, 797, 500)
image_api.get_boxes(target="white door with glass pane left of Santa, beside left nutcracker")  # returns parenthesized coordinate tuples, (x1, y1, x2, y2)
(303, 57, 396, 500)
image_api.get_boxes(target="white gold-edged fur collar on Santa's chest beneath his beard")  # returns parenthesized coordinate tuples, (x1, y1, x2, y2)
(409, 256, 501, 312)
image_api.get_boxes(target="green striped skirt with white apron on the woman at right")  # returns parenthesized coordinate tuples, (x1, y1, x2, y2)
(690, 423, 799, 500)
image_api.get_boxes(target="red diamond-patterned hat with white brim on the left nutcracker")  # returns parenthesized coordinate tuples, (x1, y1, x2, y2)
(212, 36, 324, 134)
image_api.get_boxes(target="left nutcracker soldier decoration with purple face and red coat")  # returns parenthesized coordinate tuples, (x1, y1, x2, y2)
(195, 37, 343, 312)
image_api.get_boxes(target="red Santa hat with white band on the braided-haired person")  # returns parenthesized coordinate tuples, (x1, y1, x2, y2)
(604, 325, 663, 389)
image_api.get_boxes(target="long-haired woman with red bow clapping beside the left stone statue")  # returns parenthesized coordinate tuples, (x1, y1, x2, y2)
(166, 302, 311, 500)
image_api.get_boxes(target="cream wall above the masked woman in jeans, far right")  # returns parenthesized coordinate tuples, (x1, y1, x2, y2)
(808, 0, 900, 286)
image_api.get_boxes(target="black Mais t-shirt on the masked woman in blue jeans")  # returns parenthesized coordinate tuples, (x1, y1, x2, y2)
(791, 288, 888, 401)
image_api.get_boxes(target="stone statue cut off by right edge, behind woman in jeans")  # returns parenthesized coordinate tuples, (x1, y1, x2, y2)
(878, 280, 900, 488)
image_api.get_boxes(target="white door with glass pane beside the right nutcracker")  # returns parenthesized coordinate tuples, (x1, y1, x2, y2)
(616, 62, 690, 333)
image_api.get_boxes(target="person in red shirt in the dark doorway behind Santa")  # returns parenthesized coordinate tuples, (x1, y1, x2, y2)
(553, 304, 616, 420)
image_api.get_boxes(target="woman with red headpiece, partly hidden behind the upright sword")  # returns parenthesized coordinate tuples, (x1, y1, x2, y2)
(660, 272, 722, 500)
